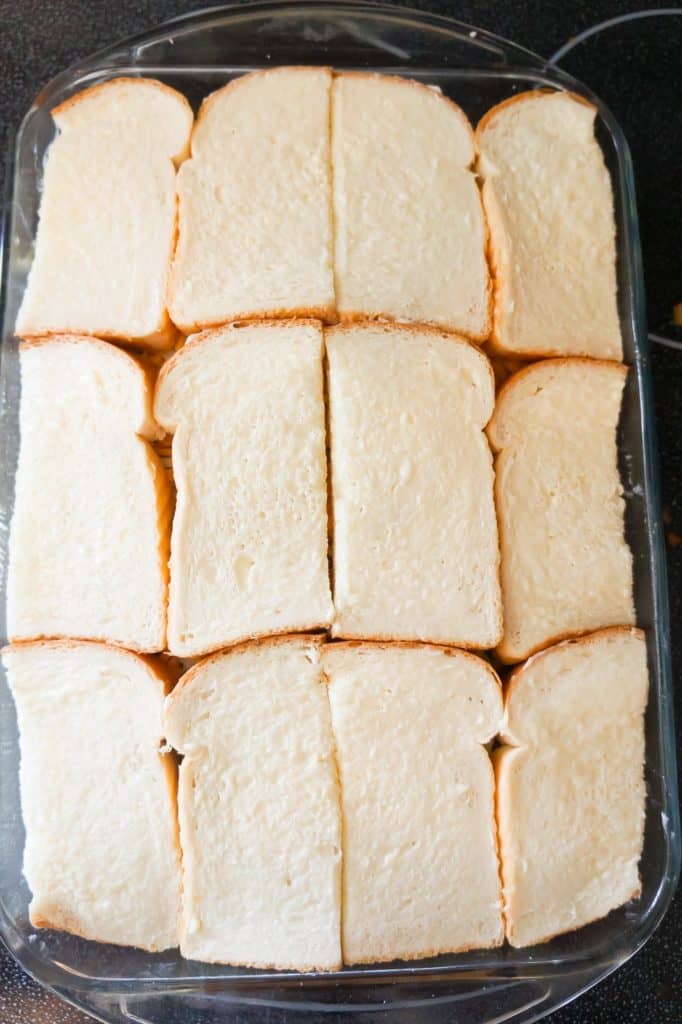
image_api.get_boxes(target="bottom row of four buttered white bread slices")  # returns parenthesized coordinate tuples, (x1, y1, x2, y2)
(3, 628, 647, 971)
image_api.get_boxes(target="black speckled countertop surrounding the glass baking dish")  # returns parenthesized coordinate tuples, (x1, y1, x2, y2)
(0, 0, 682, 1024)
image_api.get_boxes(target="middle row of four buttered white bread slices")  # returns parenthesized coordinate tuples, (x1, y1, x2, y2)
(7, 321, 635, 662)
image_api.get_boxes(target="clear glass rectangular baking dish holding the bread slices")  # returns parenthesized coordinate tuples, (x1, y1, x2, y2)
(0, 0, 680, 1024)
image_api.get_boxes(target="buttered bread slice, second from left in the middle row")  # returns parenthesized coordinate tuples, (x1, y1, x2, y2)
(156, 321, 333, 657)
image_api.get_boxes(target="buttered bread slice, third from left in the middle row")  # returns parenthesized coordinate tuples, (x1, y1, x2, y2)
(327, 325, 502, 647)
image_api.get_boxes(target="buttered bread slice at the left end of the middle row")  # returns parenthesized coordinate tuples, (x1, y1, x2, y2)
(7, 335, 171, 651)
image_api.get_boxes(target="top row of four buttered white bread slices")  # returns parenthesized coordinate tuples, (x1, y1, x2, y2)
(17, 68, 622, 359)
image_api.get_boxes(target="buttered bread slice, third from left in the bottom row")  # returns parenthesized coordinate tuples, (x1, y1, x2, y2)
(323, 643, 503, 964)
